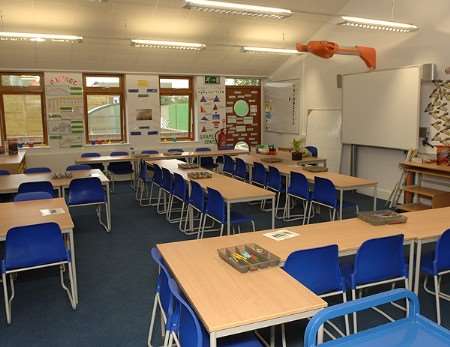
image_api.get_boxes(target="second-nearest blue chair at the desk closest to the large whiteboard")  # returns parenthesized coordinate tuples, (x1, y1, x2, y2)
(284, 172, 312, 225)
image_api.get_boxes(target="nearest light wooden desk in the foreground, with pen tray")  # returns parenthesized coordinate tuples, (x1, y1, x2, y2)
(158, 242, 326, 347)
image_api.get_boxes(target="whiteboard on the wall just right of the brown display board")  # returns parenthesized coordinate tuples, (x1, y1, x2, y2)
(263, 80, 300, 134)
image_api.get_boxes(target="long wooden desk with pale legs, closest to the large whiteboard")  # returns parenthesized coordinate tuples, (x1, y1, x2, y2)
(239, 154, 378, 219)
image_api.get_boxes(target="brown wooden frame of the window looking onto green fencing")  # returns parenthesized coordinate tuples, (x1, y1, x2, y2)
(159, 75, 195, 143)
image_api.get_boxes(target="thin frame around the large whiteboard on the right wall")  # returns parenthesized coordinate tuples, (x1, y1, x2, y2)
(340, 64, 424, 151)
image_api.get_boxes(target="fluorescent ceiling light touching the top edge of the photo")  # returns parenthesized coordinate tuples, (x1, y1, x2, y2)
(184, 0, 292, 19)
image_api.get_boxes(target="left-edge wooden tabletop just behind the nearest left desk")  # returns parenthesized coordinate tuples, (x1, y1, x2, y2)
(0, 169, 109, 193)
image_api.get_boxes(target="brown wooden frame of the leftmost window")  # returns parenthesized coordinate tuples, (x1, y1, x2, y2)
(0, 71, 48, 146)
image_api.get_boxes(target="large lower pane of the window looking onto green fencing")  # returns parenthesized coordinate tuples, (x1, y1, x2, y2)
(161, 95, 190, 137)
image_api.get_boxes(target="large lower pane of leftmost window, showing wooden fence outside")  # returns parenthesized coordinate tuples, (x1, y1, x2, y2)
(3, 94, 44, 143)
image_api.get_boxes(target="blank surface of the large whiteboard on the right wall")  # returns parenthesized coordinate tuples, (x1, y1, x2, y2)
(342, 66, 421, 150)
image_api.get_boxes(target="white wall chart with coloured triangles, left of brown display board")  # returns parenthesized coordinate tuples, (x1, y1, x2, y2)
(196, 76, 225, 145)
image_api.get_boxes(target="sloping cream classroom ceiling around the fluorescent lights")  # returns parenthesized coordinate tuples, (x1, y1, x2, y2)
(0, 0, 348, 76)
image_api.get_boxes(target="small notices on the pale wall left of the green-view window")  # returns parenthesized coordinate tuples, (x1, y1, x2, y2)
(126, 75, 161, 146)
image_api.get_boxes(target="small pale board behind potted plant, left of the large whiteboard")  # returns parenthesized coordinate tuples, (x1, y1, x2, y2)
(306, 109, 342, 172)
